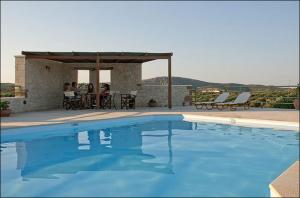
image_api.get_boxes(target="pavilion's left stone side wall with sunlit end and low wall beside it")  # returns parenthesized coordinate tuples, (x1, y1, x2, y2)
(5, 56, 77, 112)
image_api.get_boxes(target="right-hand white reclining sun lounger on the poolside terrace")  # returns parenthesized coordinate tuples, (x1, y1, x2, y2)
(216, 92, 251, 110)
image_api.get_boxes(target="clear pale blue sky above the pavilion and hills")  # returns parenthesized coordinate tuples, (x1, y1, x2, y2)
(1, 1, 299, 85)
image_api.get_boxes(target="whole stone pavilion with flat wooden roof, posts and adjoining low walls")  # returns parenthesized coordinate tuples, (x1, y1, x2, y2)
(1, 51, 188, 112)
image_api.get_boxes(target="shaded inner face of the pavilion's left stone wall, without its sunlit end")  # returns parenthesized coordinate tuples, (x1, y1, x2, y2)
(25, 60, 77, 110)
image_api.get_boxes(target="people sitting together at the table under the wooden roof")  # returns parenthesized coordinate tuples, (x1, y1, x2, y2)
(64, 82, 110, 108)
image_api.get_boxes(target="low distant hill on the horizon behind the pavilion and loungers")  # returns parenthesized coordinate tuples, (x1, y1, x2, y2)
(143, 76, 279, 91)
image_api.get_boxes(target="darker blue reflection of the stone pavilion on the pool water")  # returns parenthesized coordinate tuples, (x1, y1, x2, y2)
(16, 122, 192, 179)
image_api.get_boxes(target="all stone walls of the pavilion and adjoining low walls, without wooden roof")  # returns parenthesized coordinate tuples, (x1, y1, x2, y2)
(5, 56, 189, 112)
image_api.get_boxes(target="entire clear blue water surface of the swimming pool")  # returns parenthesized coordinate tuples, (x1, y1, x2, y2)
(1, 116, 299, 197)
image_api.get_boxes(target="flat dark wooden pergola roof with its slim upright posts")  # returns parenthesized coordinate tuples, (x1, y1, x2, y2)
(22, 51, 173, 108)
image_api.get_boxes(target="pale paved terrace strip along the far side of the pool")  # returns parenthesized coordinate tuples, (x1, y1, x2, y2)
(1, 106, 299, 128)
